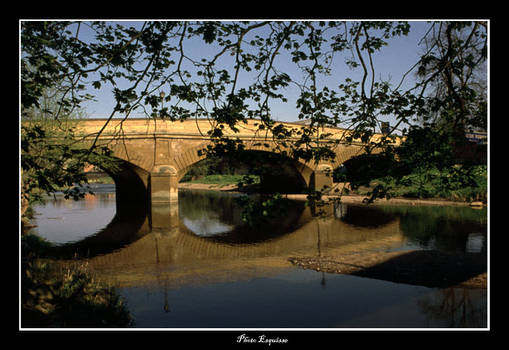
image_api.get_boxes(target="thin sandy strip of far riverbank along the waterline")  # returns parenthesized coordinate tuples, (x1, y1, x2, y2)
(178, 182, 485, 208)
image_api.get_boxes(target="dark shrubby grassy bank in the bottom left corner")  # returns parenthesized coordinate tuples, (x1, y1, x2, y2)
(21, 234, 132, 328)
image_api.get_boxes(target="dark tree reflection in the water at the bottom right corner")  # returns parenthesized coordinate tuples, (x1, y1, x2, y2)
(417, 288, 487, 327)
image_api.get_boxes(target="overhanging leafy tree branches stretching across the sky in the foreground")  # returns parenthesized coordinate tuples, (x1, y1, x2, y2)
(21, 21, 487, 202)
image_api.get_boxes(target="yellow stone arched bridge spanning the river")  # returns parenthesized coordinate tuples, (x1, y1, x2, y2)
(76, 119, 399, 205)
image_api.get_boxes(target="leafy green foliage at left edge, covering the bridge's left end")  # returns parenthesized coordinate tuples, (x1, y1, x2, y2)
(21, 76, 115, 205)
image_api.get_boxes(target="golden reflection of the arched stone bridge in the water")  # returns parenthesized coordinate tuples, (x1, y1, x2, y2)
(54, 192, 405, 287)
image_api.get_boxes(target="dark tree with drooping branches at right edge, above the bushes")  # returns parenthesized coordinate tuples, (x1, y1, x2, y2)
(410, 21, 488, 134)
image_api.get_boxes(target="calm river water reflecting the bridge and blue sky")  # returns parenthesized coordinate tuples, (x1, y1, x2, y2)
(27, 185, 489, 329)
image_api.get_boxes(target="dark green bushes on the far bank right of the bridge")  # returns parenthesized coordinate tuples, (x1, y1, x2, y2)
(342, 127, 487, 201)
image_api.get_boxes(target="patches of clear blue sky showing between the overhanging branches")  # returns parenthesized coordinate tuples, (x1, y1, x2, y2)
(74, 21, 430, 130)
